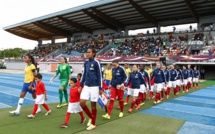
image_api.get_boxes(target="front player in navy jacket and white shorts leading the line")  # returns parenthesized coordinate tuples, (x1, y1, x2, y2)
(79, 49, 103, 130)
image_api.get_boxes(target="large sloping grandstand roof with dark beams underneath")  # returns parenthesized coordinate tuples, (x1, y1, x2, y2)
(3, 0, 215, 40)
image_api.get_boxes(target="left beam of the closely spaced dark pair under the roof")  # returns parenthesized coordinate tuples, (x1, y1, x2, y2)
(82, 10, 117, 31)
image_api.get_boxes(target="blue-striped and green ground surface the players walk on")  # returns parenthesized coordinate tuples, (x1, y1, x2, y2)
(0, 73, 215, 134)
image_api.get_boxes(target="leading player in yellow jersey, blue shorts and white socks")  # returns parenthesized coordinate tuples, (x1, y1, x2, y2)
(9, 55, 41, 115)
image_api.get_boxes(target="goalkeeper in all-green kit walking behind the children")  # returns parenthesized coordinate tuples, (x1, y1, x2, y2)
(50, 57, 71, 108)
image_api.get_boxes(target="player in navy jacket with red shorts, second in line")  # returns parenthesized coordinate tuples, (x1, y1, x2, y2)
(102, 60, 127, 119)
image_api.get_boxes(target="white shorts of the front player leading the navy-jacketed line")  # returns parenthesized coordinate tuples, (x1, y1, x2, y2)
(80, 85, 99, 102)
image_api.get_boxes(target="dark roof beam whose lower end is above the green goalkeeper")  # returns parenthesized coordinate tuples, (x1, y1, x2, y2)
(33, 22, 71, 36)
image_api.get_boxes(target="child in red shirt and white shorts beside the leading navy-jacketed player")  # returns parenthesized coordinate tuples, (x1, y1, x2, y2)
(60, 78, 86, 128)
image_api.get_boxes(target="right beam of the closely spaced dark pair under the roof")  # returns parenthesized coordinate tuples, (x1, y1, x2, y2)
(91, 8, 125, 30)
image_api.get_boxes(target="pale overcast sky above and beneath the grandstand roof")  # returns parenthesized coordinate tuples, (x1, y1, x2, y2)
(0, 0, 196, 50)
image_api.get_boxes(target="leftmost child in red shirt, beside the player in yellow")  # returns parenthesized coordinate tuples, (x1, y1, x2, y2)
(27, 74, 51, 118)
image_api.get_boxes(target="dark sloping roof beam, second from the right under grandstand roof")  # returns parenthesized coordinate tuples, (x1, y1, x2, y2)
(128, 0, 157, 26)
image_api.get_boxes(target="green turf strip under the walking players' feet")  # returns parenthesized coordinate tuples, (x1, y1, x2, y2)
(0, 80, 215, 134)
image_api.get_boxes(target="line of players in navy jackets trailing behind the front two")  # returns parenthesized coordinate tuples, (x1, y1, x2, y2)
(103, 63, 200, 109)
